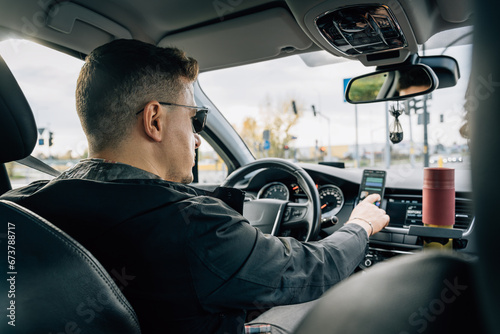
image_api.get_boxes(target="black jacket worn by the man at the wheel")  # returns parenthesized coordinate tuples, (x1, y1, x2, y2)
(1, 159, 368, 333)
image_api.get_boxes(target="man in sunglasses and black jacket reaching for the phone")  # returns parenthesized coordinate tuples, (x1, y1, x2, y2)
(1, 40, 389, 333)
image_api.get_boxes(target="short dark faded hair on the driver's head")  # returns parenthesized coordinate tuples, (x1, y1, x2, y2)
(76, 39, 198, 152)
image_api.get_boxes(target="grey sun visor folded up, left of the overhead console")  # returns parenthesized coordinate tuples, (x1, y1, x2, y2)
(158, 8, 313, 71)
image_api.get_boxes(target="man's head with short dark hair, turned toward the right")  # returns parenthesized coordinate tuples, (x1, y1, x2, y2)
(76, 40, 199, 182)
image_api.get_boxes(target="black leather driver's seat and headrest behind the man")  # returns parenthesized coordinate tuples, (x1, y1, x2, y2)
(0, 53, 140, 334)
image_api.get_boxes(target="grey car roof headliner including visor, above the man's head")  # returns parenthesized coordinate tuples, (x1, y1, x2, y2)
(0, 0, 471, 71)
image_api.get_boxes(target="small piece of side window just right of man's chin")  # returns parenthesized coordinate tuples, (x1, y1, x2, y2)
(198, 138, 227, 184)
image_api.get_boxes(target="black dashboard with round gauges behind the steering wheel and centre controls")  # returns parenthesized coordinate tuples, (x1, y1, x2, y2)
(242, 164, 476, 267)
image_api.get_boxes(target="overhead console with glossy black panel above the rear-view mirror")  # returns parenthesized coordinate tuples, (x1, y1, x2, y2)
(289, 0, 418, 66)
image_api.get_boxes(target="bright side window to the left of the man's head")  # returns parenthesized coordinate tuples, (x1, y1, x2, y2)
(0, 40, 88, 188)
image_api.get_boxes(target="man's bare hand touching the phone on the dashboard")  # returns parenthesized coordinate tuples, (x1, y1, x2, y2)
(346, 194, 390, 236)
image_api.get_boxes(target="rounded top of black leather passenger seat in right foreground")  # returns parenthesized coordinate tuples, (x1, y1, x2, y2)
(295, 251, 485, 334)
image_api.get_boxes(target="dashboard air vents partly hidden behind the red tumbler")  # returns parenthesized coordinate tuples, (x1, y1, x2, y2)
(386, 195, 474, 230)
